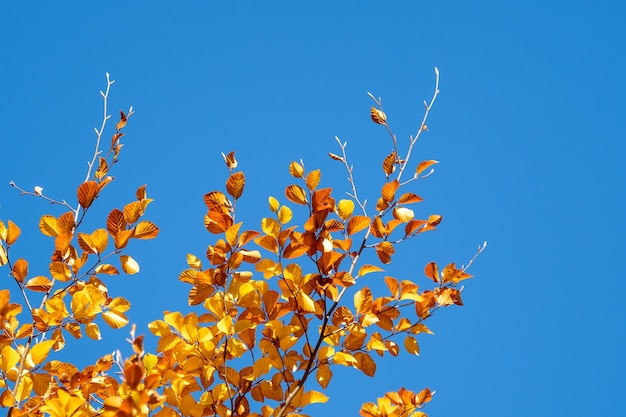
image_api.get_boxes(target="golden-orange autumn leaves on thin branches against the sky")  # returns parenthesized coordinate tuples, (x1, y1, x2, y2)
(0, 71, 484, 417)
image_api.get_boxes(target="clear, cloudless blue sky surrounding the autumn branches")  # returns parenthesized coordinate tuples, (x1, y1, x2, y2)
(0, 0, 626, 417)
